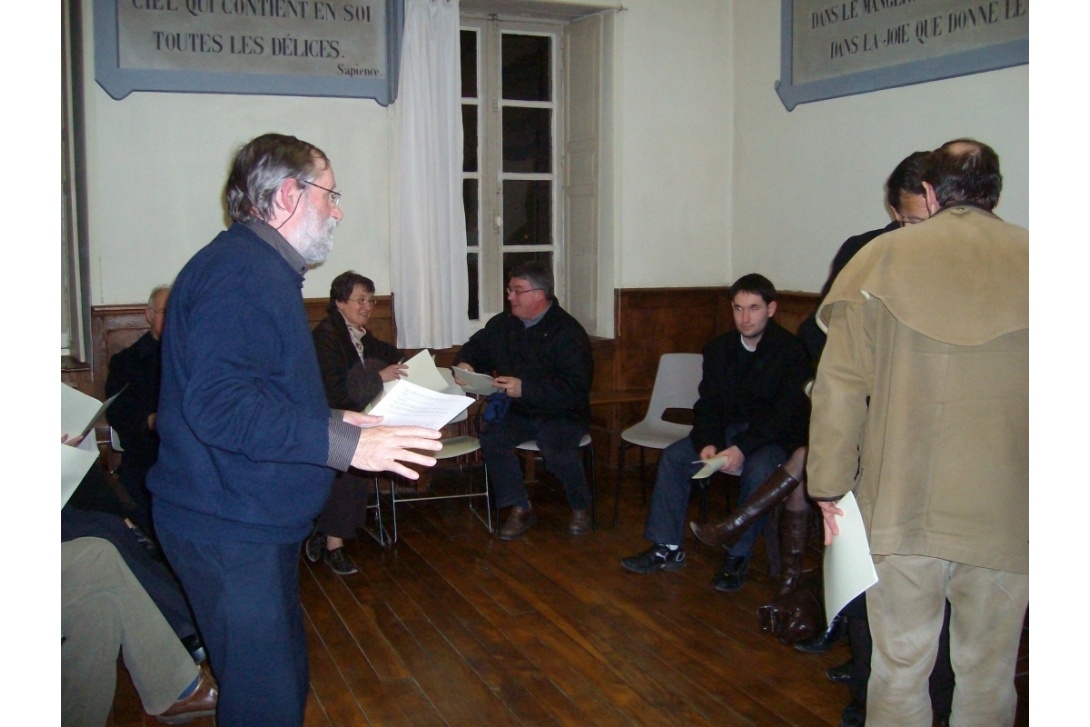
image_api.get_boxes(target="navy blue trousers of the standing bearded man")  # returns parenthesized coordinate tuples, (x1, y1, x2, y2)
(158, 523, 310, 727)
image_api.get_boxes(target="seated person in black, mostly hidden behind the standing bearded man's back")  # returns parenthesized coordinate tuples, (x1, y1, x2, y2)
(106, 286, 170, 533)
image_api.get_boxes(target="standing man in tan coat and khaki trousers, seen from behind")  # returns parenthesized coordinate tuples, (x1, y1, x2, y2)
(807, 140, 1029, 726)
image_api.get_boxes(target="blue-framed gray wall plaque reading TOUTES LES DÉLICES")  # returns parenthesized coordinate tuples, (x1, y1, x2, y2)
(95, 0, 404, 106)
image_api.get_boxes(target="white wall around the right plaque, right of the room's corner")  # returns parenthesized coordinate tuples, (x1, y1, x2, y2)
(728, 0, 1029, 291)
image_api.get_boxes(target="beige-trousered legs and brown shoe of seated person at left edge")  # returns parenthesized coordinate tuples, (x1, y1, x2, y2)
(61, 537, 219, 727)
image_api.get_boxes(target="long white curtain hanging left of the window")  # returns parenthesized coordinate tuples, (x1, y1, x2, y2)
(390, 0, 469, 349)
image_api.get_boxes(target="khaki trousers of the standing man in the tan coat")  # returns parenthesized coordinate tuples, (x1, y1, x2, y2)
(867, 555, 1029, 727)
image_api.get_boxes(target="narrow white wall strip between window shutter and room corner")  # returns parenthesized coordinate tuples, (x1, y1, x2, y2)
(615, 0, 736, 288)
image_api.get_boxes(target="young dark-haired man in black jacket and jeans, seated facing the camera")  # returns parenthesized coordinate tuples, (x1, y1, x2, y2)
(621, 272, 810, 593)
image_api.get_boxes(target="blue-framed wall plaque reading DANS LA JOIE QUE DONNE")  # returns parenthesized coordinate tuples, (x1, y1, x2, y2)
(776, 0, 1029, 111)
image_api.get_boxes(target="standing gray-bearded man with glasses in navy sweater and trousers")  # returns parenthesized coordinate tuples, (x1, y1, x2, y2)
(148, 134, 440, 727)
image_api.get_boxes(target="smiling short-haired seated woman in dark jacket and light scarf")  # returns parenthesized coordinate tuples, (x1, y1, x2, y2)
(305, 270, 405, 575)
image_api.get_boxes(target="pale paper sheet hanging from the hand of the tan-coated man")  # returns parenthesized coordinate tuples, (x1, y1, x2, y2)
(824, 493, 879, 620)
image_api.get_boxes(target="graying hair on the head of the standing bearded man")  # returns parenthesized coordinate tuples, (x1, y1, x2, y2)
(223, 134, 329, 222)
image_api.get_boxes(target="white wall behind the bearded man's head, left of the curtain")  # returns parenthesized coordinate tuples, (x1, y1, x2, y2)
(83, 0, 392, 305)
